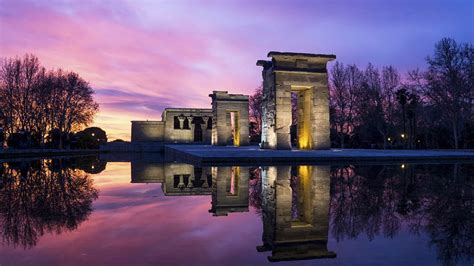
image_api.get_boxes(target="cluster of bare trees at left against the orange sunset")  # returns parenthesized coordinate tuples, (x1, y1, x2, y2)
(0, 54, 99, 148)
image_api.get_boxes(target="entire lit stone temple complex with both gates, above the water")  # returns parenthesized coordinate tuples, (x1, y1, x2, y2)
(132, 52, 336, 150)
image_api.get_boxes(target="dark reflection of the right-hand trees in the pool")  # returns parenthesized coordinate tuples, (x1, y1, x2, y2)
(331, 164, 474, 265)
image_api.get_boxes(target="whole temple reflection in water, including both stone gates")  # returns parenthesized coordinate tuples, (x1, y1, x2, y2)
(132, 162, 336, 261)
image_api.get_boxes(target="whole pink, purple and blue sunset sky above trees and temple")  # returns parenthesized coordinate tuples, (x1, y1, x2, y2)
(0, 0, 474, 140)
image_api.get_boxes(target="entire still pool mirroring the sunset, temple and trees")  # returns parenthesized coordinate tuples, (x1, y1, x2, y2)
(0, 156, 474, 266)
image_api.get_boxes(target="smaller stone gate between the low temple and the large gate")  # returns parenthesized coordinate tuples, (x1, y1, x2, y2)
(209, 91, 249, 146)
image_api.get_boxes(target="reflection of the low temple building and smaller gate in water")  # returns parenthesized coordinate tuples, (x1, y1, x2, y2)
(132, 162, 250, 216)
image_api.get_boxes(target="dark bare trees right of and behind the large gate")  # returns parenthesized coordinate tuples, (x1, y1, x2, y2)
(250, 38, 474, 149)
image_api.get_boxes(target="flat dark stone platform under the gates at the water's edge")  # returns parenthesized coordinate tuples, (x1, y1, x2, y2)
(165, 145, 474, 164)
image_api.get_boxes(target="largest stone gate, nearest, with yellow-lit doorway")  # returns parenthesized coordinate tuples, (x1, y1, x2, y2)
(257, 52, 336, 150)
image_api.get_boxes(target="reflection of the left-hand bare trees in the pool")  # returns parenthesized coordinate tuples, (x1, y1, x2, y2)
(0, 159, 100, 249)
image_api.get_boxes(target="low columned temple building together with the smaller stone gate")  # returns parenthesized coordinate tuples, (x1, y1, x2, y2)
(131, 91, 249, 146)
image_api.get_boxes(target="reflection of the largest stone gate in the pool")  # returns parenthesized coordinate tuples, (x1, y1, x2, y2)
(257, 166, 336, 261)
